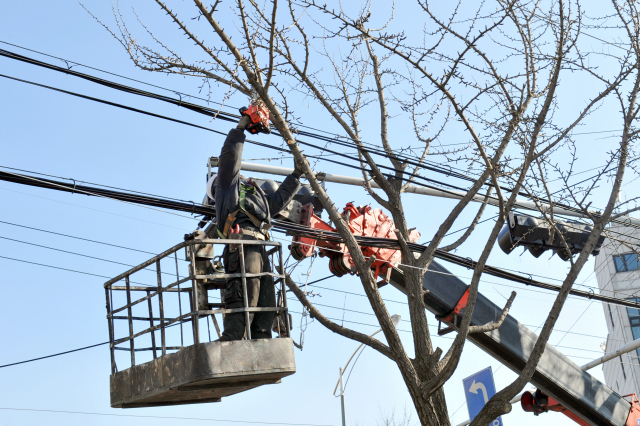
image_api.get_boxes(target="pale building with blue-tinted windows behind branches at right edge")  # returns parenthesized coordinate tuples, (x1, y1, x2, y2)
(595, 226, 640, 395)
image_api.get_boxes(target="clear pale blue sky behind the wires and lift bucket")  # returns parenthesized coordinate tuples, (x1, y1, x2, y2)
(0, 0, 632, 426)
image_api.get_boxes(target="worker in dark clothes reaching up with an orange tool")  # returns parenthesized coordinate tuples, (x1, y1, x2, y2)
(210, 115, 304, 341)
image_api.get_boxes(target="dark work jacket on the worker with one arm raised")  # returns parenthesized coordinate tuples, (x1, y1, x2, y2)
(214, 129, 300, 232)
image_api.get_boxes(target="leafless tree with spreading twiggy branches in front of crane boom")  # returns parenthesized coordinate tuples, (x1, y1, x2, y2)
(86, 0, 640, 426)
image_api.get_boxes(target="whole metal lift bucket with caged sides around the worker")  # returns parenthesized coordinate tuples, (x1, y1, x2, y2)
(104, 239, 296, 408)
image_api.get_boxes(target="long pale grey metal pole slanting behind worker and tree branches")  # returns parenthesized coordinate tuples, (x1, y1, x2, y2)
(216, 157, 640, 225)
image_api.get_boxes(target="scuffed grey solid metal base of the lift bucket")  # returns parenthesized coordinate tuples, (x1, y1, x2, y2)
(110, 338, 296, 408)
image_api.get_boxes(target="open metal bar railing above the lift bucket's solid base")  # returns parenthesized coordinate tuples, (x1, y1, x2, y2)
(104, 239, 291, 374)
